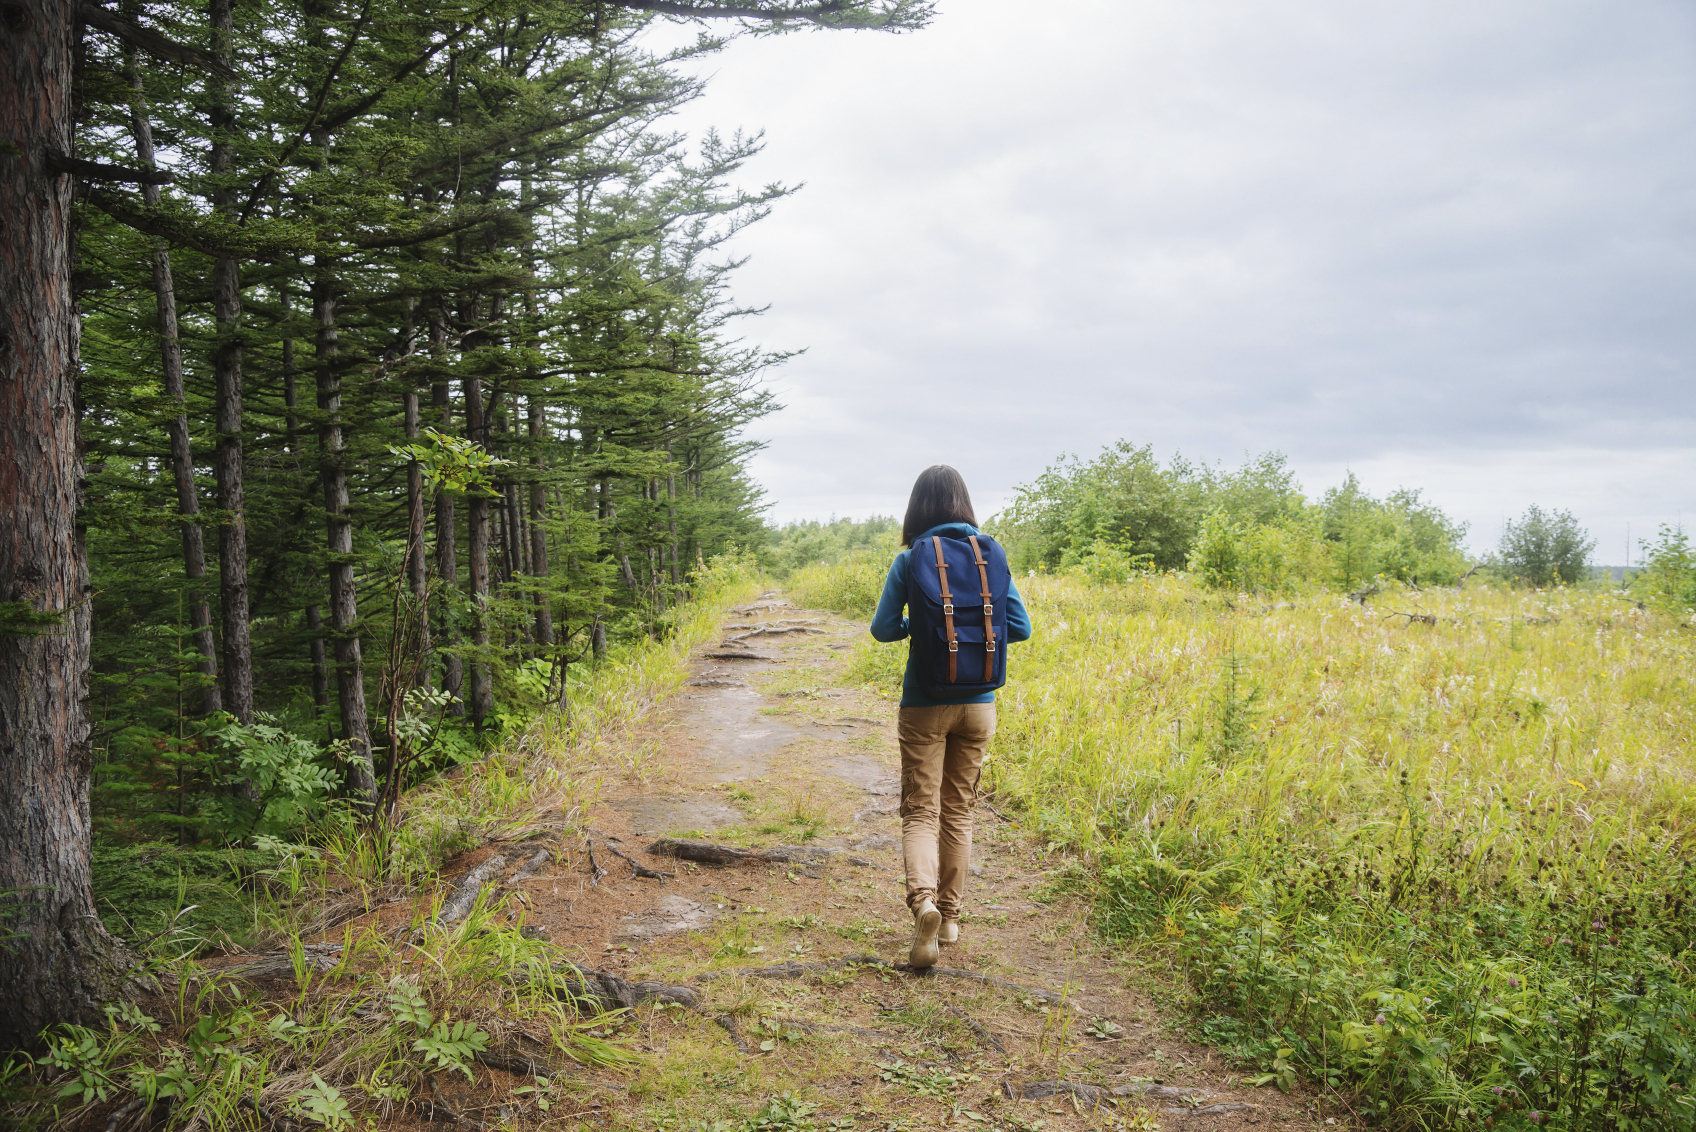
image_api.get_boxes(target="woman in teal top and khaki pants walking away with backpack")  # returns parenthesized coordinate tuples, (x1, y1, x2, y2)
(872, 463, 1031, 967)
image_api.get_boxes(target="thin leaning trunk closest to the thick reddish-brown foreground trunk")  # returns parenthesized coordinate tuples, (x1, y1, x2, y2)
(124, 35, 224, 715)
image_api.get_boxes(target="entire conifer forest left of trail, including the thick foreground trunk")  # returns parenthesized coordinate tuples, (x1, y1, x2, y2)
(0, 0, 931, 1052)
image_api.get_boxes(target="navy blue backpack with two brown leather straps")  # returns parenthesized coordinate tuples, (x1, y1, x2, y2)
(907, 535, 1013, 699)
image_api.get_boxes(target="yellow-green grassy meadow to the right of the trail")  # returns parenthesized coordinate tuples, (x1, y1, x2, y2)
(848, 575, 1696, 1129)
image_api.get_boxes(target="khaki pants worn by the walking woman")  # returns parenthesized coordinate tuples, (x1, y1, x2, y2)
(895, 703, 996, 920)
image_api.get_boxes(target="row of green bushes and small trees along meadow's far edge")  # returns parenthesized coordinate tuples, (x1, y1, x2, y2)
(763, 441, 1696, 608)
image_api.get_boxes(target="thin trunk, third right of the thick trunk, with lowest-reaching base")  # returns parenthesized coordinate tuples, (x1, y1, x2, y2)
(312, 261, 377, 806)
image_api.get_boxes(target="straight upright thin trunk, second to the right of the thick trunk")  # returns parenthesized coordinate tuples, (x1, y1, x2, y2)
(209, 0, 253, 723)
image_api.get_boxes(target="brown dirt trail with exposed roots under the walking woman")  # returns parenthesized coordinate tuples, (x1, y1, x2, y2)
(368, 592, 1348, 1132)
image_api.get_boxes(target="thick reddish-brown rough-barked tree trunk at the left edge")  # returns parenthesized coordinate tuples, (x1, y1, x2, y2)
(0, 0, 138, 1047)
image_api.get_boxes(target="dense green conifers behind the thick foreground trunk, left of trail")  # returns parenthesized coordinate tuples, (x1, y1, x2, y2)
(78, 0, 942, 840)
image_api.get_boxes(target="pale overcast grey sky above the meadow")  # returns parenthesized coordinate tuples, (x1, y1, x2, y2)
(644, 0, 1696, 562)
